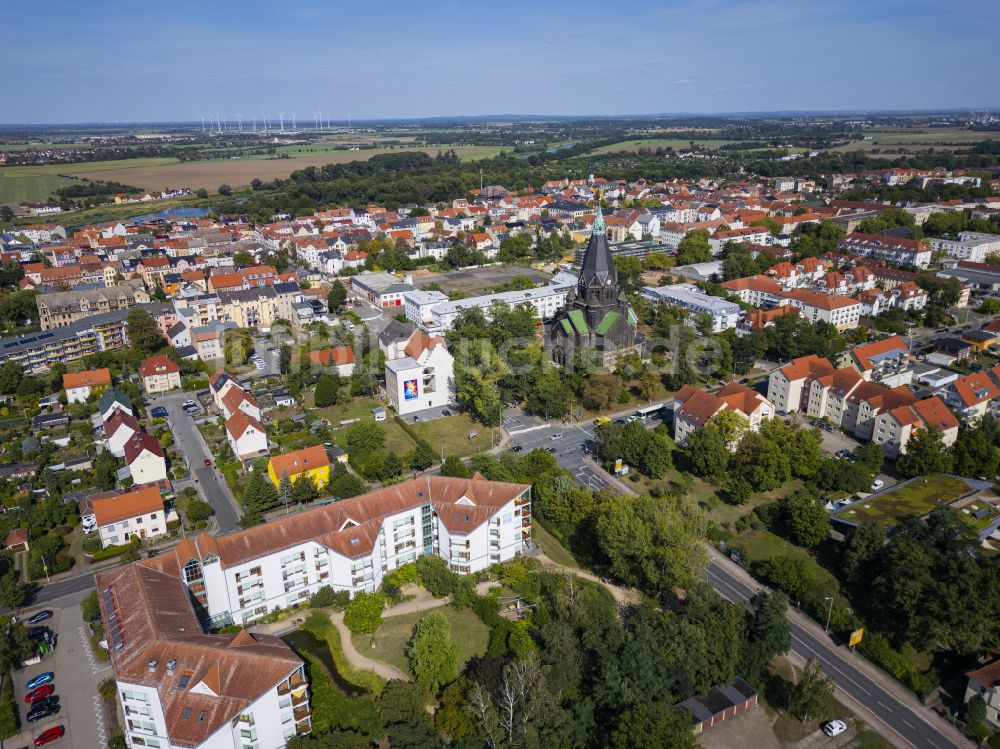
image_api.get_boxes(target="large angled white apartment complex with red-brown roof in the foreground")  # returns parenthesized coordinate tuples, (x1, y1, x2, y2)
(97, 476, 531, 749)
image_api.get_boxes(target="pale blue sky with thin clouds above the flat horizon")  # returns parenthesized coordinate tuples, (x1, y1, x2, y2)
(7, 0, 1000, 124)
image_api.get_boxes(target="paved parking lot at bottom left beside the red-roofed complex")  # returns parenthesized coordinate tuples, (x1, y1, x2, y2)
(11, 594, 111, 749)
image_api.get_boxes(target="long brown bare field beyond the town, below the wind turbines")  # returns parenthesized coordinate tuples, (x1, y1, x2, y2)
(60, 146, 503, 191)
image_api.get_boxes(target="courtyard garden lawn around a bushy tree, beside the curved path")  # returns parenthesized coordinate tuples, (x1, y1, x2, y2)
(351, 606, 490, 674)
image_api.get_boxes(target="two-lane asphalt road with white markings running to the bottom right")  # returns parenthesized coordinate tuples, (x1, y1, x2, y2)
(708, 555, 970, 749)
